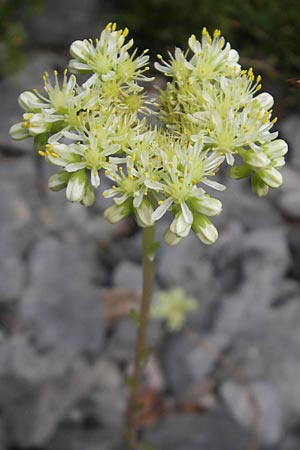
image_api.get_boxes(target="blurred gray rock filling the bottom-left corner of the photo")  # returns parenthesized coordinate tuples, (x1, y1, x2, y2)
(0, 335, 108, 448)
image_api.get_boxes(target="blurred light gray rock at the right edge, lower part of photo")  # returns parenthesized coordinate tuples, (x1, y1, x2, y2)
(224, 298, 300, 427)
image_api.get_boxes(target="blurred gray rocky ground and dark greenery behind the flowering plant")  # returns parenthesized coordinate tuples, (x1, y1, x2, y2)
(0, 0, 300, 450)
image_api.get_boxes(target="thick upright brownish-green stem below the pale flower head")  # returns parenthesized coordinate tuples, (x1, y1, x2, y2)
(127, 226, 155, 450)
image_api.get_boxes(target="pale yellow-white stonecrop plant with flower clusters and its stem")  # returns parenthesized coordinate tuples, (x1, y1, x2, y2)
(10, 23, 287, 450)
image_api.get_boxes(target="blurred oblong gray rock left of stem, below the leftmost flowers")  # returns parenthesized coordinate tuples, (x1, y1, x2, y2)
(20, 237, 104, 355)
